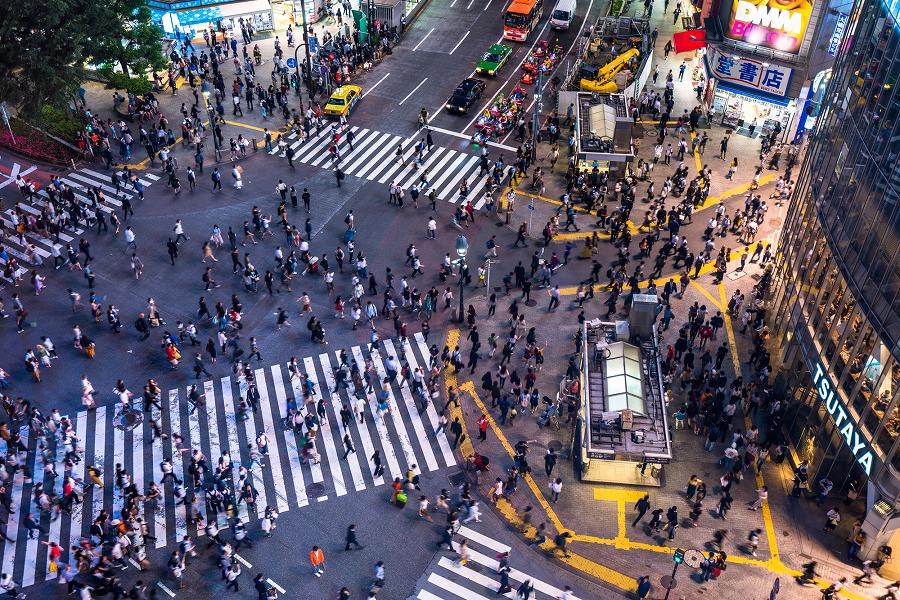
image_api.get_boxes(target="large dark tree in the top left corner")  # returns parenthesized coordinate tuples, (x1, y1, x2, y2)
(0, 0, 93, 116)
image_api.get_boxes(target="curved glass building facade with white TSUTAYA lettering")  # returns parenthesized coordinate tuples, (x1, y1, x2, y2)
(770, 0, 900, 557)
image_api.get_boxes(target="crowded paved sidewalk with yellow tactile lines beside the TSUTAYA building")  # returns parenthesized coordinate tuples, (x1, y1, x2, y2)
(442, 3, 889, 600)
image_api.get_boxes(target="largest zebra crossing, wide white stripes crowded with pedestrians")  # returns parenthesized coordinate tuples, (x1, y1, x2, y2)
(0, 334, 456, 586)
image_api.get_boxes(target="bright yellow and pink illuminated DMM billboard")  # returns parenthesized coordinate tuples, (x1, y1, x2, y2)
(725, 0, 812, 54)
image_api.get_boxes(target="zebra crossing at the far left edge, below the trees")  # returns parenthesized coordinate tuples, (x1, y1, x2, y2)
(0, 165, 160, 265)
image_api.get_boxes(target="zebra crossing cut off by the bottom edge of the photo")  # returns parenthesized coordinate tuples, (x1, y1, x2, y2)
(415, 526, 578, 600)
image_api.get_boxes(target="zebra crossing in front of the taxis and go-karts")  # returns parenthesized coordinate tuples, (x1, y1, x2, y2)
(269, 126, 489, 209)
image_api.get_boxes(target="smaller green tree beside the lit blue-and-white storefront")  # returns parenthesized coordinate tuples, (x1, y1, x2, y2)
(86, 0, 167, 79)
